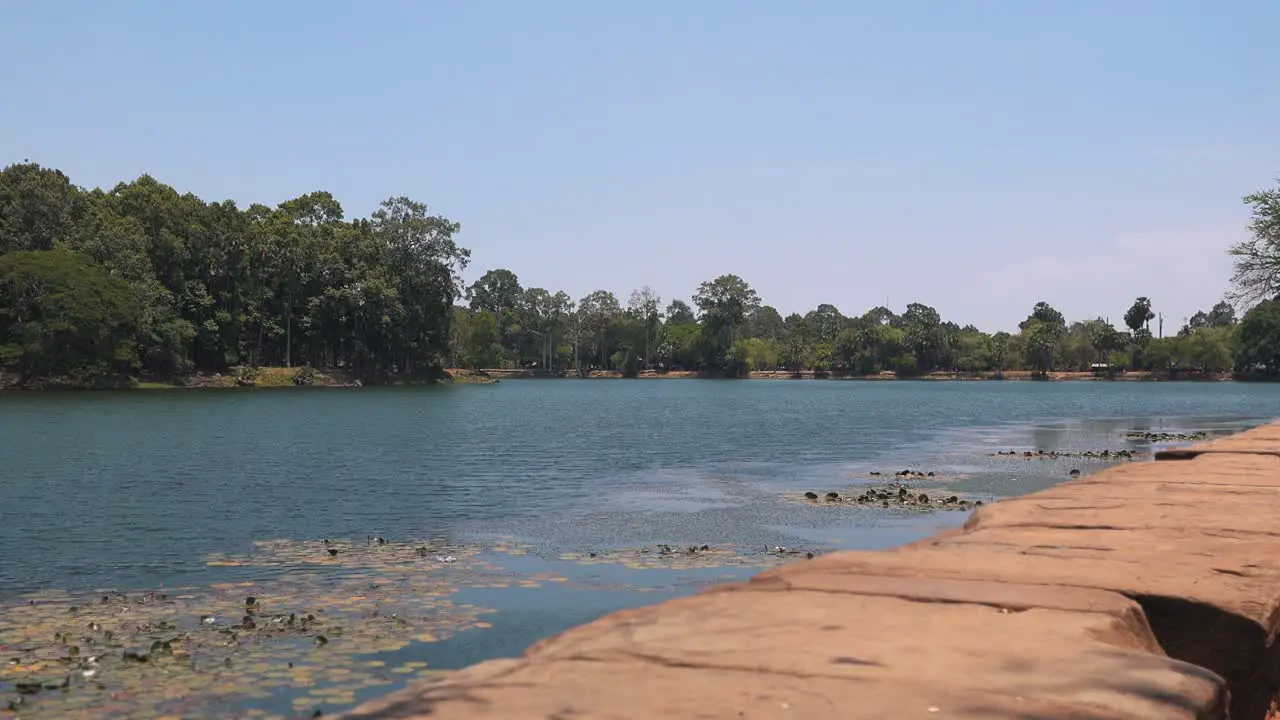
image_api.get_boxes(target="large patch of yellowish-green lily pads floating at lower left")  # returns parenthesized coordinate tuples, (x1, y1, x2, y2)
(0, 538, 804, 719)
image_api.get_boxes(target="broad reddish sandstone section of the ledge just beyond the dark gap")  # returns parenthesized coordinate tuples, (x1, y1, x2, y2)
(753, 456, 1280, 617)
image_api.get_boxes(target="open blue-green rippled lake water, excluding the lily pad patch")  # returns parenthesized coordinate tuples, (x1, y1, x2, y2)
(0, 380, 1280, 716)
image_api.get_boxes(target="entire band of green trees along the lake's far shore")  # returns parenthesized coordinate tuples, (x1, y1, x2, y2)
(0, 163, 1280, 388)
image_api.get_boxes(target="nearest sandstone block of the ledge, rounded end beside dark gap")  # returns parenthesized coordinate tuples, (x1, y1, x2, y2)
(345, 591, 1225, 719)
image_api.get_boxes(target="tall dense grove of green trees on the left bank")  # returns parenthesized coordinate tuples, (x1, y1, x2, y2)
(0, 164, 468, 377)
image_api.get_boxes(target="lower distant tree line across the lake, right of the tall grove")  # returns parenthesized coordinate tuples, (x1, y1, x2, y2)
(451, 269, 1259, 375)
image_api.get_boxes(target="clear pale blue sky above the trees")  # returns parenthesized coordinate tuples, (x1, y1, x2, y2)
(0, 0, 1280, 332)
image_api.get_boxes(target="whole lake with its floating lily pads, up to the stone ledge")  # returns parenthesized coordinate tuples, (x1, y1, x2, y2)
(0, 379, 1280, 717)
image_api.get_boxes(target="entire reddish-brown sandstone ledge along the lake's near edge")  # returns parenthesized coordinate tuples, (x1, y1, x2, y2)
(348, 424, 1280, 720)
